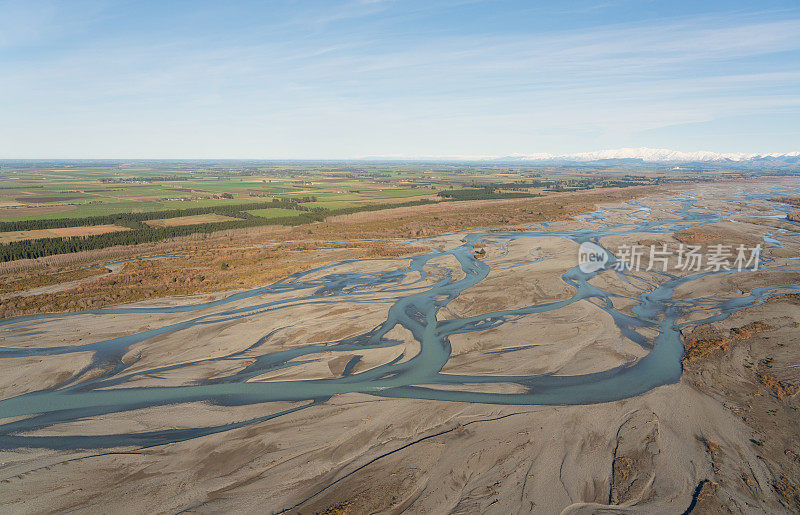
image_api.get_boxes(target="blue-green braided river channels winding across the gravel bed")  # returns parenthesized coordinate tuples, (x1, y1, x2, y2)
(0, 191, 800, 448)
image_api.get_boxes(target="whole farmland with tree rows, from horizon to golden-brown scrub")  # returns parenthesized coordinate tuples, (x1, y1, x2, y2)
(0, 161, 672, 261)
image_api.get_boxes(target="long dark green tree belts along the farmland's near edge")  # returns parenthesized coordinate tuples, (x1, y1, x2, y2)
(0, 199, 434, 262)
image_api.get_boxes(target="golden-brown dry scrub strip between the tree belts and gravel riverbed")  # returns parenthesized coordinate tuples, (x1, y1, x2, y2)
(0, 188, 652, 318)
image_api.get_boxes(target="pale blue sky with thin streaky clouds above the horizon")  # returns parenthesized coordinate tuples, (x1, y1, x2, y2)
(0, 0, 800, 159)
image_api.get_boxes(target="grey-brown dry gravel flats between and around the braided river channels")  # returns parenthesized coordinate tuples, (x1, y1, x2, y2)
(0, 179, 800, 514)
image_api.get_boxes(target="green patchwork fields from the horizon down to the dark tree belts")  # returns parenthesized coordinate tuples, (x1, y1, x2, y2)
(0, 161, 664, 228)
